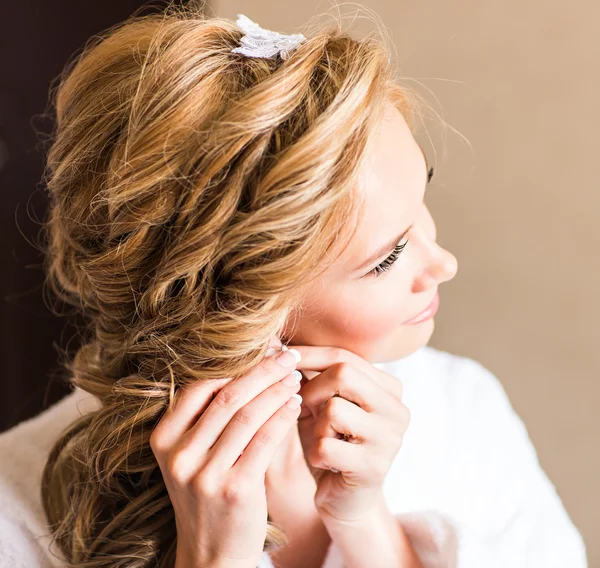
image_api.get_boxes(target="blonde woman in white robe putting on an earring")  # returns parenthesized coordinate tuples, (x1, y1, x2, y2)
(0, 1, 586, 568)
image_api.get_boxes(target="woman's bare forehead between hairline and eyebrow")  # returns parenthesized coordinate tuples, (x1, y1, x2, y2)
(339, 103, 426, 271)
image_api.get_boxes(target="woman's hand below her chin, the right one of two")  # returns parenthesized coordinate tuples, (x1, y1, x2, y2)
(289, 345, 410, 522)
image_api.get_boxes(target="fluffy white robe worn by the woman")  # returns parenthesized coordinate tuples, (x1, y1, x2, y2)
(0, 346, 587, 568)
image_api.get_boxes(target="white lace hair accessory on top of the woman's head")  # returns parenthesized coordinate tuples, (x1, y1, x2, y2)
(231, 14, 306, 59)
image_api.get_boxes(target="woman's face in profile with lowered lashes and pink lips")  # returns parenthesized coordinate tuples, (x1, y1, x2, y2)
(285, 99, 457, 363)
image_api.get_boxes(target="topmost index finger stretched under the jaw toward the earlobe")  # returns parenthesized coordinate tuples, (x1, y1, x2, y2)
(293, 345, 403, 401)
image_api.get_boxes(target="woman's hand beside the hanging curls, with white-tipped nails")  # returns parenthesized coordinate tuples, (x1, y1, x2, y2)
(150, 339, 302, 568)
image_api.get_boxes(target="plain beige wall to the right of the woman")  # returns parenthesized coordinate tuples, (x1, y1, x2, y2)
(209, 0, 600, 568)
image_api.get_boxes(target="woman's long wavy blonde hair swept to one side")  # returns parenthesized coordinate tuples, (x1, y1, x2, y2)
(42, 4, 424, 568)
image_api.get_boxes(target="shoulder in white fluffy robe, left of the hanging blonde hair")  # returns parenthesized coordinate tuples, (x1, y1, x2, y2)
(0, 388, 98, 567)
